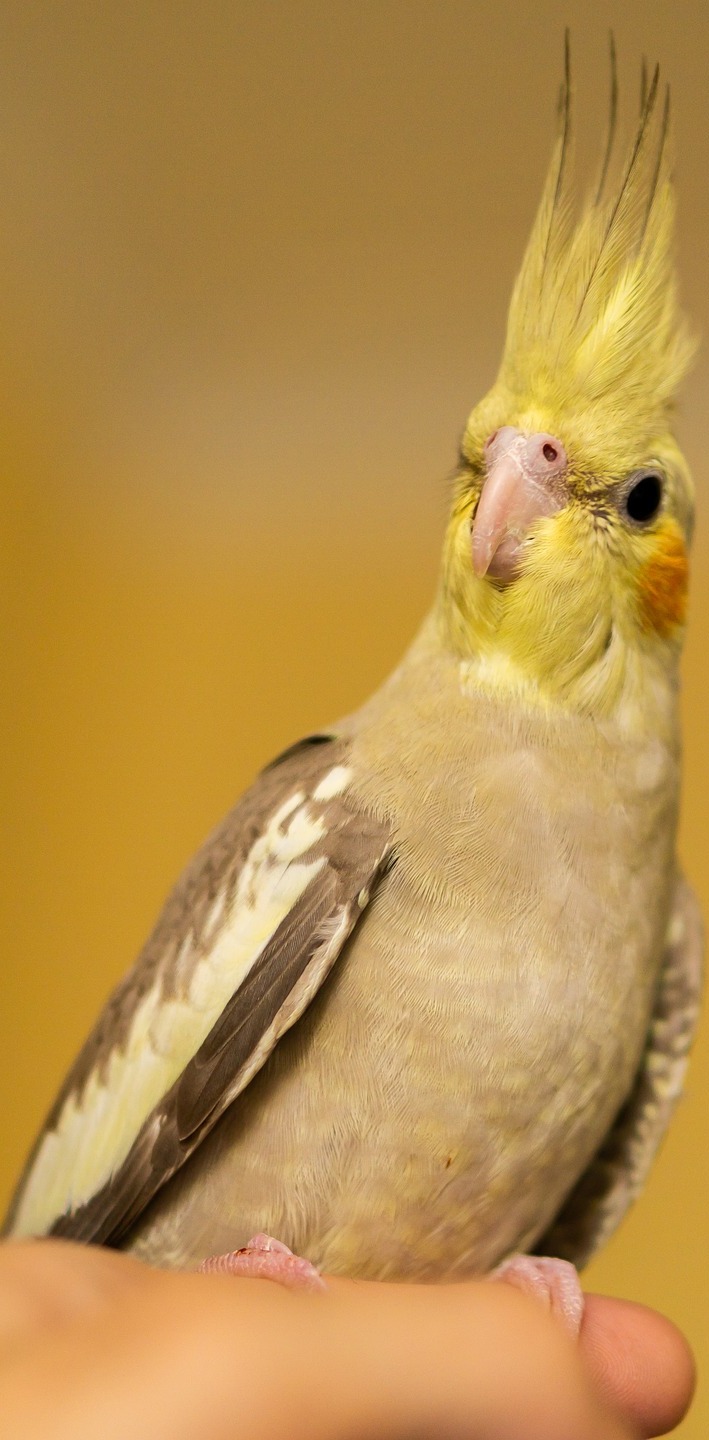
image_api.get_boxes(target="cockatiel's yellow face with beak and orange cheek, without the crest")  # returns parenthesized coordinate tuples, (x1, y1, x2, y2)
(442, 392, 692, 714)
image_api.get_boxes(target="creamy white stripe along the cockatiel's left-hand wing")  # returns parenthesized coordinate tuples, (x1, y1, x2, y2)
(13, 791, 326, 1236)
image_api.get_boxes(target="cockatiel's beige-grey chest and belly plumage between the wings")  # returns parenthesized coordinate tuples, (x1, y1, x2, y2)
(124, 668, 676, 1279)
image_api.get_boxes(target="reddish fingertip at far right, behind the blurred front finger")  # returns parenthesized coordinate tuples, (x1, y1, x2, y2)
(581, 1295, 696, 1436)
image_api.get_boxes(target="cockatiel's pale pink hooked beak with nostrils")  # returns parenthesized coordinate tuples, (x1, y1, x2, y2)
(473, 425, 568, 580)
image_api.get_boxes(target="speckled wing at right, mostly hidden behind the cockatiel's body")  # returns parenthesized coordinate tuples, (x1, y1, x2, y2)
(535, 877, 703, 1269)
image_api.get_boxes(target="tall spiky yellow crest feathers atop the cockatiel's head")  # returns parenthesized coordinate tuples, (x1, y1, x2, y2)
(497, 36, 695, 431)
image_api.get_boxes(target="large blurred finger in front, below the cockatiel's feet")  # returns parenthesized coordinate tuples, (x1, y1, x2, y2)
(0, 1270, 627, 1440)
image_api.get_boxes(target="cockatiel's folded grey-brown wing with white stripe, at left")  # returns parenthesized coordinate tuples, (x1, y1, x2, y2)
(6, 736, 391, 1244)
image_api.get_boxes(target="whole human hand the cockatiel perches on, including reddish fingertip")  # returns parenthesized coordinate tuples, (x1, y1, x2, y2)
(0, 1241, 693, 1440)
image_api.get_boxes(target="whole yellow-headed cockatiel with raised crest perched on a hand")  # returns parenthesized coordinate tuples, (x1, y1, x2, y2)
(6, 50, 702, 1319)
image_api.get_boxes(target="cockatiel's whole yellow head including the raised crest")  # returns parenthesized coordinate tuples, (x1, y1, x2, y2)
(440, 49, 693, 716)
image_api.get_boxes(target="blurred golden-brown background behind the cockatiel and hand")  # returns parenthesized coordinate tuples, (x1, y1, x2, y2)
(0, 0, 709, 1440)
